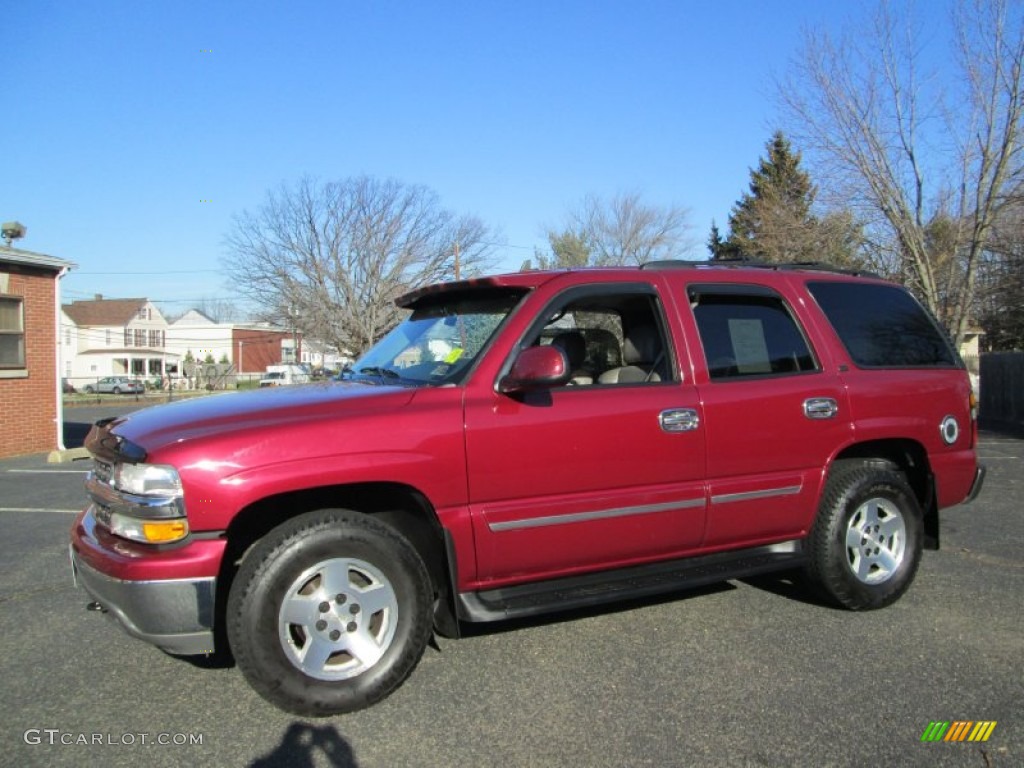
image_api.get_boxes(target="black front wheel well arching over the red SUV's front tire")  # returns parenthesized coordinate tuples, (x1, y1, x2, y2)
(214, 482, 458, 651)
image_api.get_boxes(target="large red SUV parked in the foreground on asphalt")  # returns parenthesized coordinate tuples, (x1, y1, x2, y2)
(71, 262, 984, 716)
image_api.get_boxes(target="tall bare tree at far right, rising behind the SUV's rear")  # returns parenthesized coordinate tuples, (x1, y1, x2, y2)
(779, 0, 1024, 343)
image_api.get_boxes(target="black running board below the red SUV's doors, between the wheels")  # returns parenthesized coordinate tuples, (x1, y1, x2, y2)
(456, 540, 806, 622)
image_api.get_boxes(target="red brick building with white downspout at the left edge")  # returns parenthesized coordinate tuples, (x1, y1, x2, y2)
(0, 246, 74, 458)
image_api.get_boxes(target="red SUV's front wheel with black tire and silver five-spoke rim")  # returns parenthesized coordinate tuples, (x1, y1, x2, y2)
(226, 509, 433, 717)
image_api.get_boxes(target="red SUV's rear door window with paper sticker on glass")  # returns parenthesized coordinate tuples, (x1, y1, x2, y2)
(690, 291, 817, 381)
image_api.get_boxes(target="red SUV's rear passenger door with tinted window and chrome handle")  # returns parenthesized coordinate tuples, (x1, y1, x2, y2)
(686, 283, 851, 547)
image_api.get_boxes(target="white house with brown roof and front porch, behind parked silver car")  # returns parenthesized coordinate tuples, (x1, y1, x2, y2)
(59, 296, 178, 387)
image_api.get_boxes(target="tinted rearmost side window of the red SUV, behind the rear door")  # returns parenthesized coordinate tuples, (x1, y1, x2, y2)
(808, 283, 959, 368)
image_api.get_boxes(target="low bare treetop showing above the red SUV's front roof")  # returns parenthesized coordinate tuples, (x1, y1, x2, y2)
(537, 193, 694, 268)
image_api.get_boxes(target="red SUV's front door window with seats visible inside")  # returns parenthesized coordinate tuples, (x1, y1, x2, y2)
(527, 291, 674, 386)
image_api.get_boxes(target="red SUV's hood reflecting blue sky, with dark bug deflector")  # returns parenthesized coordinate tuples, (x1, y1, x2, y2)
(86, 382, 416, 461)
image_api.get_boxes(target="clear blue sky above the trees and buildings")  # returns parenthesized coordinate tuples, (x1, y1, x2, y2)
(0, 0, 865, 309)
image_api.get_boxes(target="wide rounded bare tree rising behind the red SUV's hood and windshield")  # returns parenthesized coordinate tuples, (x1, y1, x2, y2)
(224, 176, 493, 354)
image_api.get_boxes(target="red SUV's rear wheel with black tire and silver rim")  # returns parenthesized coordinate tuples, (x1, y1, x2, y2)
(807, 462, 924, 610)
